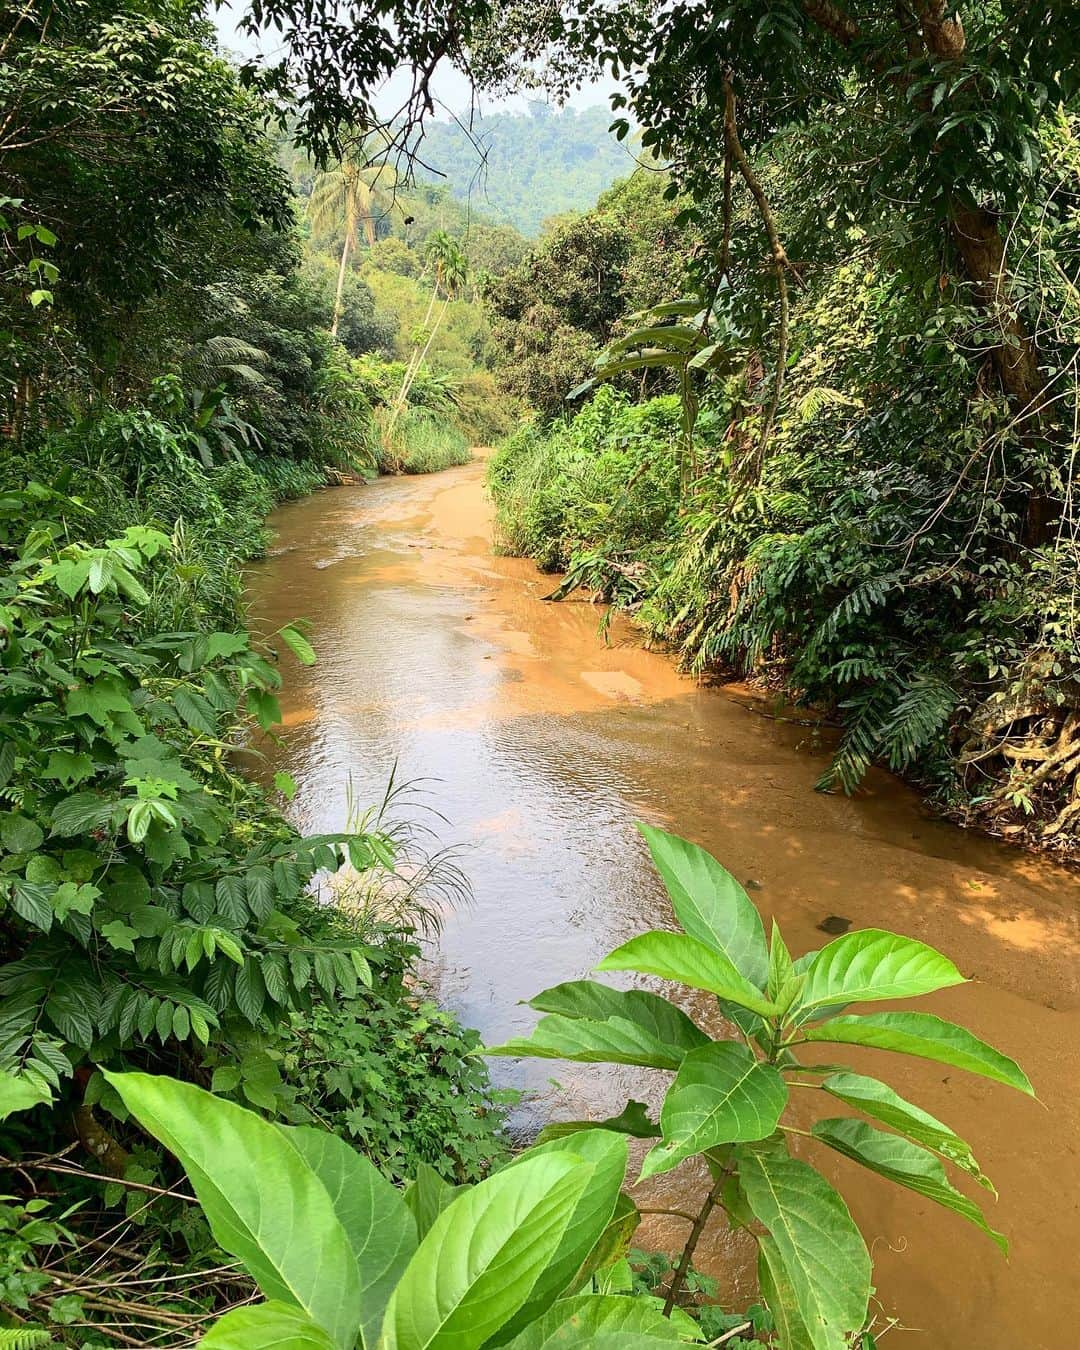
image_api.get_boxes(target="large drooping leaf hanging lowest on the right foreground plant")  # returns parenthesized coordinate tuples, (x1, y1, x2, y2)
(736, 1141, 871, 1350)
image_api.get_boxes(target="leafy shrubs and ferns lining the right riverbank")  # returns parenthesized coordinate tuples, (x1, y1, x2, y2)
(491, 105, 1077, 844)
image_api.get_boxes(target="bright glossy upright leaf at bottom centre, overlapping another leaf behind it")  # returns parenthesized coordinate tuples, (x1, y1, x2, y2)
(382, 1152, 594, 1350)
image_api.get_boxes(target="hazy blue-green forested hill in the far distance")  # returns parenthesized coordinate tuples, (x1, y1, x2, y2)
(413, 103, 633, 236)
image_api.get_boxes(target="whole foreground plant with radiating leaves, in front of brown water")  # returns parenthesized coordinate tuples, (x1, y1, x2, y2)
(486, 826, 1033, 1350)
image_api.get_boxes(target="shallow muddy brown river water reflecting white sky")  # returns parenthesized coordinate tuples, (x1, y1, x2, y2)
(244, 463, 1080, 1350)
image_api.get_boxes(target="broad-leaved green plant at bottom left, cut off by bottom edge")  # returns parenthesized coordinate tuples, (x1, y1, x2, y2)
(99, 1073, 699, 1350)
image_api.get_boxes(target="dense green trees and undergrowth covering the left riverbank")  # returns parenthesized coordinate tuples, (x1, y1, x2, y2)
(0, 4, 504, 1345)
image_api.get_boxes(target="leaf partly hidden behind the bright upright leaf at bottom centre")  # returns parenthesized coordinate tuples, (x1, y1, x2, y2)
(493, 1130, 628, 1345)
